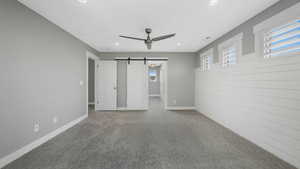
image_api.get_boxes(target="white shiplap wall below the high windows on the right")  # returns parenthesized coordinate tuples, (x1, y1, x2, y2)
(195, 54, 300, 168)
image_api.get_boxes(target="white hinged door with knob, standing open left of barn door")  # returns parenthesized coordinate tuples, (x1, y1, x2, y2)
(95, 61, 117, 110)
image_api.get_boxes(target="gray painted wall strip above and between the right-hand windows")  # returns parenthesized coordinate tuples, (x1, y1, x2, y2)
(196, 0, 300, 67)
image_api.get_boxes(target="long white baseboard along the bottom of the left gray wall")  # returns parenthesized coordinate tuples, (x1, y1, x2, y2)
(0, 114, 88, 168)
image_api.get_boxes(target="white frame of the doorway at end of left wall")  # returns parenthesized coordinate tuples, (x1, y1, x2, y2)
(86, 51, 100, 116)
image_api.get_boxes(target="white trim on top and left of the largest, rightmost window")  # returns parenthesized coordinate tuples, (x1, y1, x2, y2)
(253, 3, 300, 59)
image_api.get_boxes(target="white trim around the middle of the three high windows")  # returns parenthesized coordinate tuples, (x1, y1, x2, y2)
(218, 33, 243, 67)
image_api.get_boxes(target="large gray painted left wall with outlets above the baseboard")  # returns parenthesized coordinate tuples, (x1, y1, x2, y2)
(0, 0, 99, 158)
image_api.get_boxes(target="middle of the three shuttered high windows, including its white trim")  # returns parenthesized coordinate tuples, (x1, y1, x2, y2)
(218, 34, 242, 67)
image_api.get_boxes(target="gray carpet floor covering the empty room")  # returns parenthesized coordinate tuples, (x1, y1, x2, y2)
(5, 99, 294, 169)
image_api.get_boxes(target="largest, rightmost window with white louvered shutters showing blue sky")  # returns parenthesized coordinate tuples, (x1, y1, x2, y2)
(264, 19, 300, 58)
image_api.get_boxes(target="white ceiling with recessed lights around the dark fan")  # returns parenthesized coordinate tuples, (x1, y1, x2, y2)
(19, 0, 278, 52)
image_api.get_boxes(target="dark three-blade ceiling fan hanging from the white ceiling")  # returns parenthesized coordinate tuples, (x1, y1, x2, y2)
(120, 28, 176, 50)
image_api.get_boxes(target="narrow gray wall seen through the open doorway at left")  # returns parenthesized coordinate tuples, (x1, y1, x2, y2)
(89, 59, 95, 103)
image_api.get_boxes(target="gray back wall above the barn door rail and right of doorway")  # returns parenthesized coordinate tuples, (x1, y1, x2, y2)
(99, 52, 196, 107)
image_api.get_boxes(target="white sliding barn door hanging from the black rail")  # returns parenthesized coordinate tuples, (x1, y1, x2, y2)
(127, 61, 148, 110)
